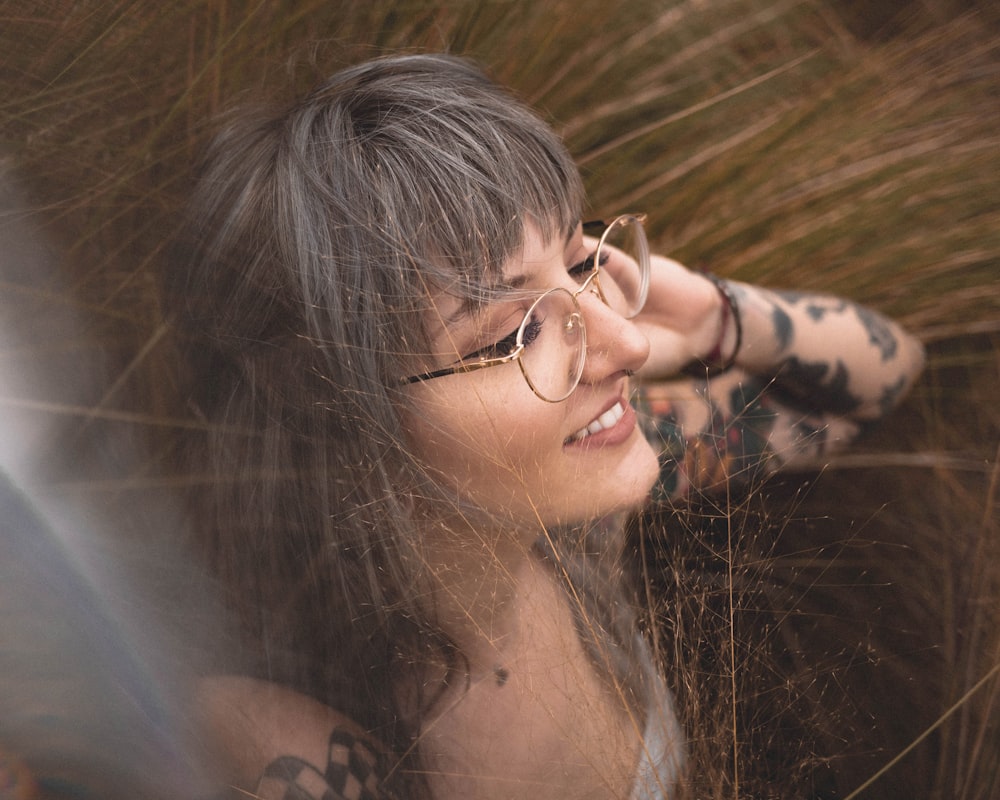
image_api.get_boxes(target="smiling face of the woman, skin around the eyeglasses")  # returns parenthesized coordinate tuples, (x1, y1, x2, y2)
(407, 226, 657, 526)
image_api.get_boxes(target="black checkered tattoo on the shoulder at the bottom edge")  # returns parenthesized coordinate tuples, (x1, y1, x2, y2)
(260, 728, 386, 800)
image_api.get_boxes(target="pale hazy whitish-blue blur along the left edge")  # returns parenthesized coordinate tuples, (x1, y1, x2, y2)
(0, 177, 218, 800)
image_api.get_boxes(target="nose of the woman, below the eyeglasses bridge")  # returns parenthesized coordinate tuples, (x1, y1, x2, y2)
(577, 290, 649, 383)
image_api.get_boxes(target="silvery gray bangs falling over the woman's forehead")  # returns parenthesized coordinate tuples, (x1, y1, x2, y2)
(308, 56, 583, 303)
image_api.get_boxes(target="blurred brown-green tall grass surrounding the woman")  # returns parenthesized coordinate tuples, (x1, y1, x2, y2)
(0, 0, 1000, 800)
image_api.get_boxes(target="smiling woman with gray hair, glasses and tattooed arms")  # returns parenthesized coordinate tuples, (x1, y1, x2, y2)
(174, 56, 922, 798)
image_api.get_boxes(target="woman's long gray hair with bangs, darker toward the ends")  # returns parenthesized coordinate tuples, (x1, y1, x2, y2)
(172, 56, 583, 796)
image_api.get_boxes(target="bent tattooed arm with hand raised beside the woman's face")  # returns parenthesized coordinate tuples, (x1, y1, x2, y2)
(637, 258, 923, 499)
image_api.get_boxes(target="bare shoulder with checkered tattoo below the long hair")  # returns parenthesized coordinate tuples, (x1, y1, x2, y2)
(198, 676, 387, 800)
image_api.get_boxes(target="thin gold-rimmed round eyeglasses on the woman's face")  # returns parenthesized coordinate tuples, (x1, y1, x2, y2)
(402, 214, 649, 403)
